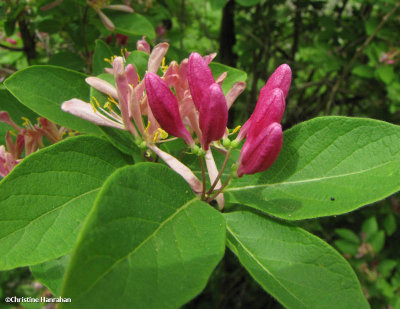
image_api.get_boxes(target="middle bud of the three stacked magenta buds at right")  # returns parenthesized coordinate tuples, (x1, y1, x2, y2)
(247, 88, 285, 139)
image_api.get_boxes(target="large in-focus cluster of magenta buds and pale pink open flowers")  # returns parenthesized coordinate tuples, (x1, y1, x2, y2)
(62, 38, 291, 208)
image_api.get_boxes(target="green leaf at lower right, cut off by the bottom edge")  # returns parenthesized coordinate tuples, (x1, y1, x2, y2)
(224, 211, 369, 309)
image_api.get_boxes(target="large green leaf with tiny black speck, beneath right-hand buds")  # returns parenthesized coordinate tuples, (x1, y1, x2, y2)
(225, 117, 400, 220)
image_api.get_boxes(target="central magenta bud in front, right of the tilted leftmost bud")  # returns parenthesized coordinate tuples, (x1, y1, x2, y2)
(199, 83, 228, 150)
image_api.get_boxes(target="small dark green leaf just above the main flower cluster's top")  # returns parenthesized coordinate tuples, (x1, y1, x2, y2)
(107, 11, 156, 40)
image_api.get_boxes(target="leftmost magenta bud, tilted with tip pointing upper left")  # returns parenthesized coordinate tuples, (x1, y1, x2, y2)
(145, 72, 194, 145)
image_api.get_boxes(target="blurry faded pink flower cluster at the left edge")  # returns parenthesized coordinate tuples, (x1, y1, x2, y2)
(0, 111, 68, 178)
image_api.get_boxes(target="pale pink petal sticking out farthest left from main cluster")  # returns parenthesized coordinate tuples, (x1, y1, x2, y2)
(61, 99, 125, 130)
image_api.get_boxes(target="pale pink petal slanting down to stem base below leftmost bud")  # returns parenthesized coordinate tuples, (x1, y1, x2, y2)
(148, 145, 203, 194)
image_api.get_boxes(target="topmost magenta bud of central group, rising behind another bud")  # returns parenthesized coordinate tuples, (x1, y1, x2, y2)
(187, 53, 215, 111)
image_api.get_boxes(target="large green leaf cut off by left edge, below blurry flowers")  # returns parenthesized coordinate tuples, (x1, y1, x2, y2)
(0, 136, 127, 270)
